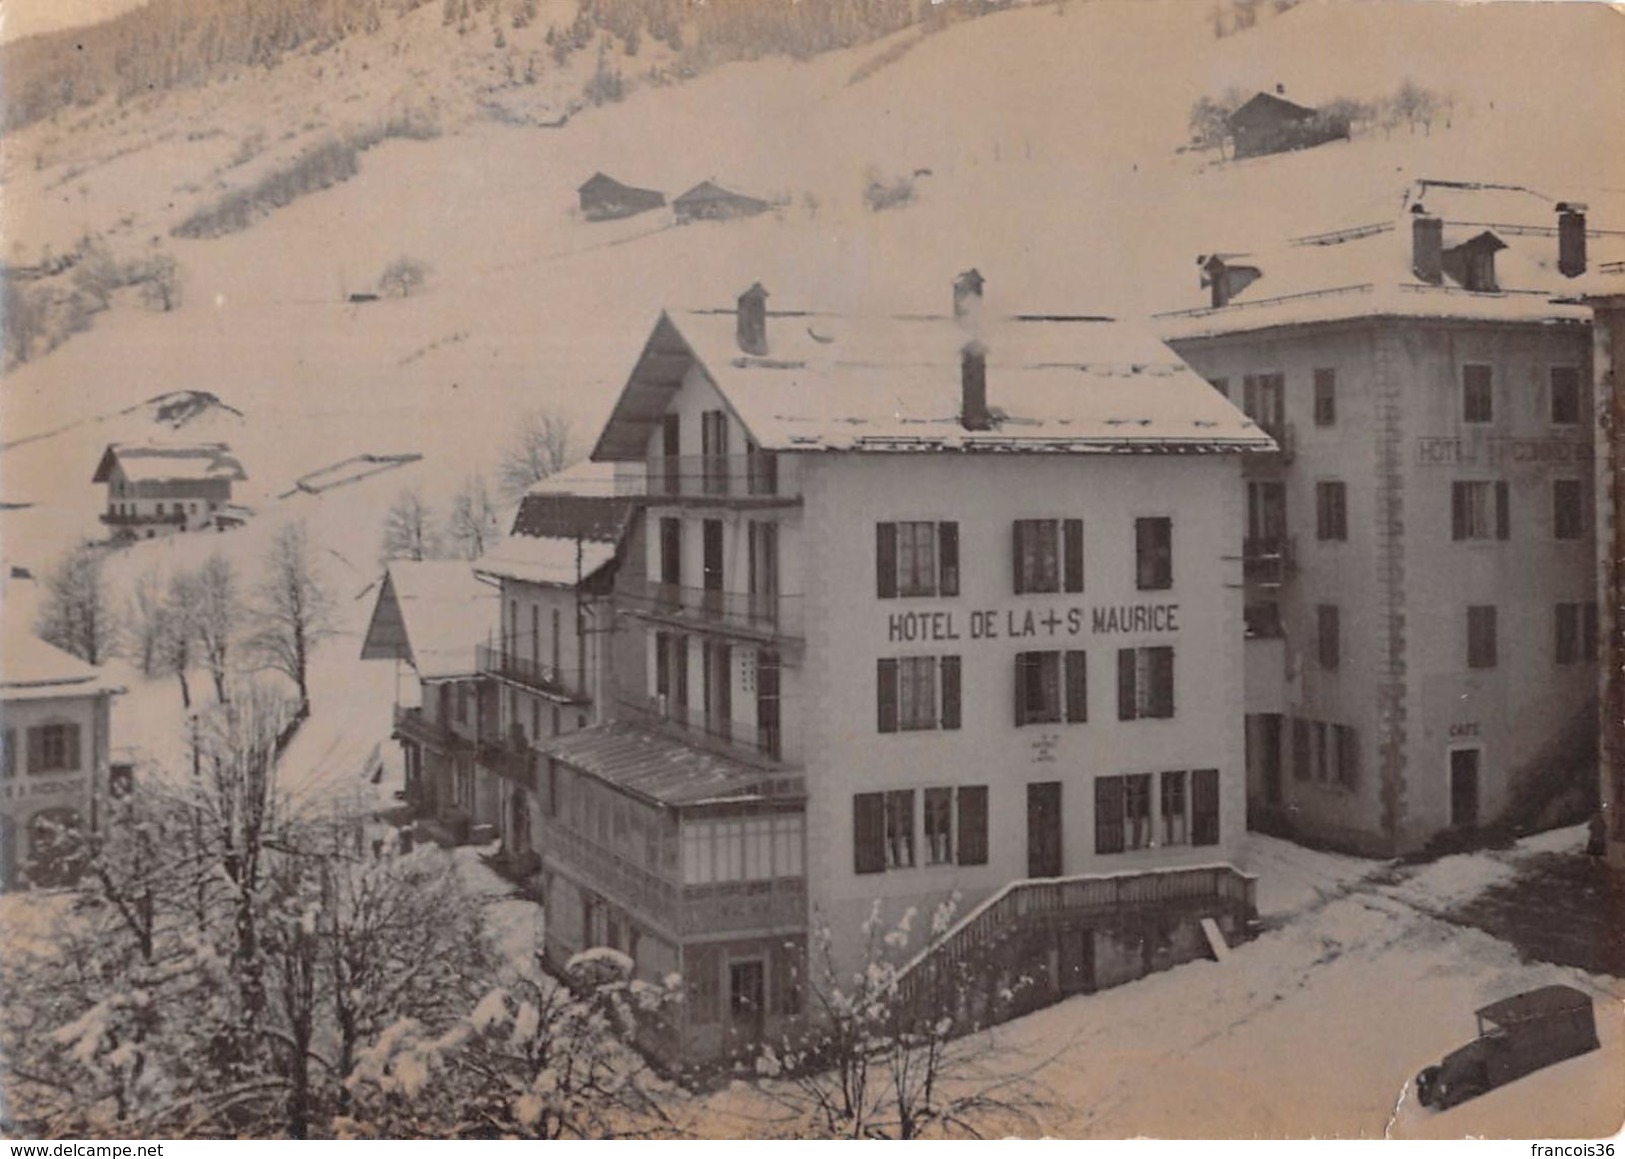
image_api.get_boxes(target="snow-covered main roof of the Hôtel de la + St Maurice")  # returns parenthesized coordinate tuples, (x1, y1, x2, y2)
(593, 310, 1272, 462)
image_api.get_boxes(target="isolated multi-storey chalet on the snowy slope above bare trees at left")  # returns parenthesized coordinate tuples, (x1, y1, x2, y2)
(91, 442, 247, 540)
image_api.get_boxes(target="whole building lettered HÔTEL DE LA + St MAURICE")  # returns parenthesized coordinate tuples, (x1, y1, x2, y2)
(533, 271, 1272, 1060)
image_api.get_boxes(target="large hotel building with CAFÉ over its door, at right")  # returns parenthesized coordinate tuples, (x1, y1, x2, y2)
(1160, 182, 1599, 853)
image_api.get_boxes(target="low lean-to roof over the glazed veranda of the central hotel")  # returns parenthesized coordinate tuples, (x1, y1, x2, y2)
(536, 720, 799, 805)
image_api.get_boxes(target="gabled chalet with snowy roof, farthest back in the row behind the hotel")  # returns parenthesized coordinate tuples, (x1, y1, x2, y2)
(361, 559, 501, 844)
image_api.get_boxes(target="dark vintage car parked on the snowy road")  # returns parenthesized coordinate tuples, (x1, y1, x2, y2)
(1417, 985, 1599, 1110)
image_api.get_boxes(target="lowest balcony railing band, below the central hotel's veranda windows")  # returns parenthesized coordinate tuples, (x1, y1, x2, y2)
(543, 819, 808, 936)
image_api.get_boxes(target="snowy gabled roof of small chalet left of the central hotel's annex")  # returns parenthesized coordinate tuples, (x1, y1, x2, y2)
(361, 559, 502, 679)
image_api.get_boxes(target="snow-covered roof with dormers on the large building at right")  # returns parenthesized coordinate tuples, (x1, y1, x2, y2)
(1155, 180, 1625, 341)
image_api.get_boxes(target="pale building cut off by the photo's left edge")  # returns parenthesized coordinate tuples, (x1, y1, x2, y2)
(0, 621, 119, 889)
